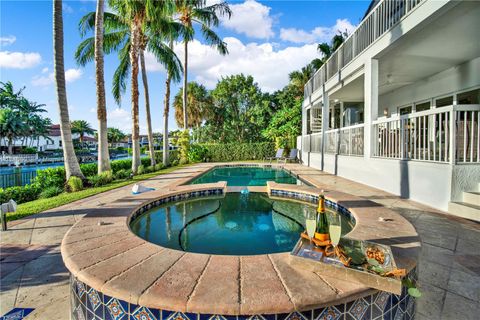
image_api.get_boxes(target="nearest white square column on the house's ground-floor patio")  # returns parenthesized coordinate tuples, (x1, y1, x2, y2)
(363, 59, 378, 158)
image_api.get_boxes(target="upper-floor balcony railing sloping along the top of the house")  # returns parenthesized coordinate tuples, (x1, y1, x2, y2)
(304, 0, 424, 99)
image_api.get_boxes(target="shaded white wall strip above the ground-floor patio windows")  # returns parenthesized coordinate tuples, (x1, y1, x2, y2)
(378, 57, 480, 115)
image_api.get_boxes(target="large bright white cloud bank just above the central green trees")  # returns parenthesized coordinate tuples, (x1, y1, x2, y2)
(146, 37, 318, 92)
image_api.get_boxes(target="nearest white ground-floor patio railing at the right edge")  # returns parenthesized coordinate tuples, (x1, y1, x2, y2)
(373, 105, 480, 163)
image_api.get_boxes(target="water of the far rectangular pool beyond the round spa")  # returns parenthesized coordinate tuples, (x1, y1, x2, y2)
(189, 167, 301, 186)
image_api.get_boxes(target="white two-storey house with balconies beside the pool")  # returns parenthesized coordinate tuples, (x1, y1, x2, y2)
(298, 0, 480, 220)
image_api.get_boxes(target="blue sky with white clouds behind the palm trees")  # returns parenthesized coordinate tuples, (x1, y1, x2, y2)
(0, 0, 370, 134)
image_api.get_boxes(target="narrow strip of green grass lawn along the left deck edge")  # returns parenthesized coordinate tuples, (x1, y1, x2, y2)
(7, 164, 189, 221)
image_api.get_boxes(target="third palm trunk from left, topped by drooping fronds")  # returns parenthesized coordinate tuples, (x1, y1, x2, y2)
(130, 19, 140, 174)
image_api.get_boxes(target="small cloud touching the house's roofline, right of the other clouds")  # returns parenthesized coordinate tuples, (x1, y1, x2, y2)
(280, 19, 355, 43)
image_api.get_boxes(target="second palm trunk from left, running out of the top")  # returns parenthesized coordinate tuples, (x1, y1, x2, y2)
(95, 0, 110, 174)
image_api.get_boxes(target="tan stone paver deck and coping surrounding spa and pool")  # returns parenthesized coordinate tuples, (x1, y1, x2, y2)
(0, 164, 480, 319)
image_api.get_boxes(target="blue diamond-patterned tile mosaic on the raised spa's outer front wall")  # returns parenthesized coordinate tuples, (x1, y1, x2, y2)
(69, 269, 416, 320)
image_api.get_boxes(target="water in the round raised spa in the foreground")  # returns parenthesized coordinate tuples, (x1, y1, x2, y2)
(130, 193, 352, 255)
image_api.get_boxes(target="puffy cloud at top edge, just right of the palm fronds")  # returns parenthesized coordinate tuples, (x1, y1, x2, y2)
(222, 0, 275, 39)
